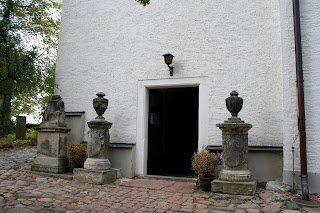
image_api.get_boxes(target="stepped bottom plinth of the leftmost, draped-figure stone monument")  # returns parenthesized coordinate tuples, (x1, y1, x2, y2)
(31, 156, 69, 174)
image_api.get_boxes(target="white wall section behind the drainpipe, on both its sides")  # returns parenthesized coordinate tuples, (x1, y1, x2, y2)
(280, 0, 320, 193)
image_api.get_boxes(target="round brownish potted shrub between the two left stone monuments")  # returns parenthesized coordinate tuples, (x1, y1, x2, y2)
(68, 141, 87, 172)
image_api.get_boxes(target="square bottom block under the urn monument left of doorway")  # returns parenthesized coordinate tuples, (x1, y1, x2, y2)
(73, 168, 117, 184)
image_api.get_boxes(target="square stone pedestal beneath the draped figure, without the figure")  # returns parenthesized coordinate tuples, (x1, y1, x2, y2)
(31, 127, 71, 173)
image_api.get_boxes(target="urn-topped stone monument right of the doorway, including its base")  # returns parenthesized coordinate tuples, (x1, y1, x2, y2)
(211, 91, 257, 195)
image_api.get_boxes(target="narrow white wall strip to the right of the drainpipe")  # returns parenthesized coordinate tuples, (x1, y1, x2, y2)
(301, 0, 320, 176)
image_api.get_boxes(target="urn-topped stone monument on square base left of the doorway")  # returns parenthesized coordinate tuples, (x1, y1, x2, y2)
(73, 92, 117, 184)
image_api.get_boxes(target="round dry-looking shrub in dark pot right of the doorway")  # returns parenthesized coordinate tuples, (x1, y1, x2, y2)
(192, 147, 218, 191)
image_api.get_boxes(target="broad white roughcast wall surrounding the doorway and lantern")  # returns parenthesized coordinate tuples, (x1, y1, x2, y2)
(55, 0, 283, 175)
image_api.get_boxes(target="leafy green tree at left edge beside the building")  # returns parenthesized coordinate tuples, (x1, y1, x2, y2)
(0, 0, 61, 135)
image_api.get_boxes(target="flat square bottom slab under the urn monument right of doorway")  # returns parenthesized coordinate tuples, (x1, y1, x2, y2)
(211, 180, 257, 195)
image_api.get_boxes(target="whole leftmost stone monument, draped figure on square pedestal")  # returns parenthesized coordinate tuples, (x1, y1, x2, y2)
(31, 95, 71, 173)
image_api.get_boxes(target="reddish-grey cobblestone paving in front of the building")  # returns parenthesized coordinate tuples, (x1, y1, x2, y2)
(0, 148, 320, 213)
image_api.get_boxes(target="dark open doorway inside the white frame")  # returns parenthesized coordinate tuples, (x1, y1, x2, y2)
(147, 87, 199, 177)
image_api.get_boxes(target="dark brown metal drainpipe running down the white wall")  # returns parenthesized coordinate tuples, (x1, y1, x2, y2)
(292, 0, 309, 200)
